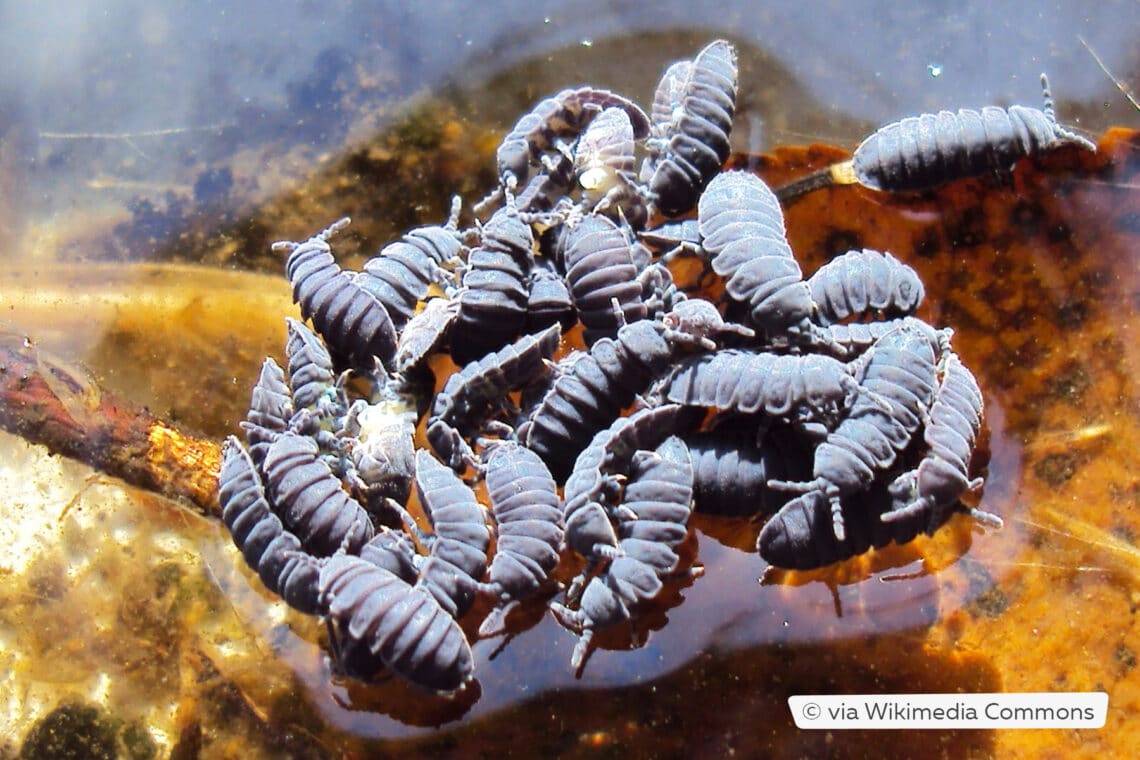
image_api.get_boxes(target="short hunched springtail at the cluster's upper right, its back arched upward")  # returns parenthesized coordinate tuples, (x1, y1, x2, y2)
(807, 248, 926, 325)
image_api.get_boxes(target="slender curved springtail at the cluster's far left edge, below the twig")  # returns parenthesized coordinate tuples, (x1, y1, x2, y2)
(218, 436, 320, 615)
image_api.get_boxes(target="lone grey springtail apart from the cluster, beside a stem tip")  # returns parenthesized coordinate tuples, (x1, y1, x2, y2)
(853, 74, 1096, 191)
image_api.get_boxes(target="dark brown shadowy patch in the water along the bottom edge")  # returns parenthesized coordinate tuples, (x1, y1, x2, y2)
(316, 634, 1001, 758)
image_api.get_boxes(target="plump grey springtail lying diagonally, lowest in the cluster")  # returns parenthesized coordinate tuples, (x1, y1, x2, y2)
(320, 554, 473, 692)
